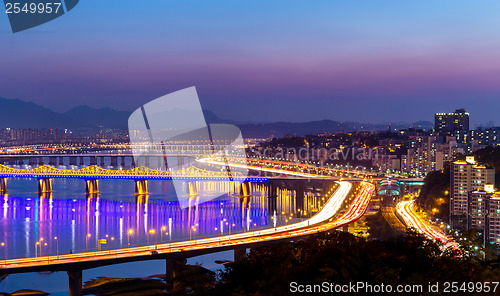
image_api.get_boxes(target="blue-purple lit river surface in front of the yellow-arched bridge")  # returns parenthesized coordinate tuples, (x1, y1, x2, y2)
(0, 187, 268, 258)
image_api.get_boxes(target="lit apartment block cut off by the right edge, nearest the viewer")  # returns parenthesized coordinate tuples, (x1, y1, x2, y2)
(467, 184, 500, 245)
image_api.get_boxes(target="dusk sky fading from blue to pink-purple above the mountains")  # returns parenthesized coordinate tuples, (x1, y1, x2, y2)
(0, 0, 500, 127)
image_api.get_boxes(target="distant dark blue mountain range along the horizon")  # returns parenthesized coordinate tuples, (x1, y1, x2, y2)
(0, 98, 434, 138)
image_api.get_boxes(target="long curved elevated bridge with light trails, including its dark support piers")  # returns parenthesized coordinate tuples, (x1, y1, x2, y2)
(1, 181, 375, 296)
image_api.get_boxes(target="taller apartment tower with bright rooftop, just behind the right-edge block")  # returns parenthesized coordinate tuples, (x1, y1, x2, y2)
(450, 156, 495, 226)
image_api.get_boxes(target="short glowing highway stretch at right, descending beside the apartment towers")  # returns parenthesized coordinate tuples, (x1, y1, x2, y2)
(396, 200, 460, 251)
